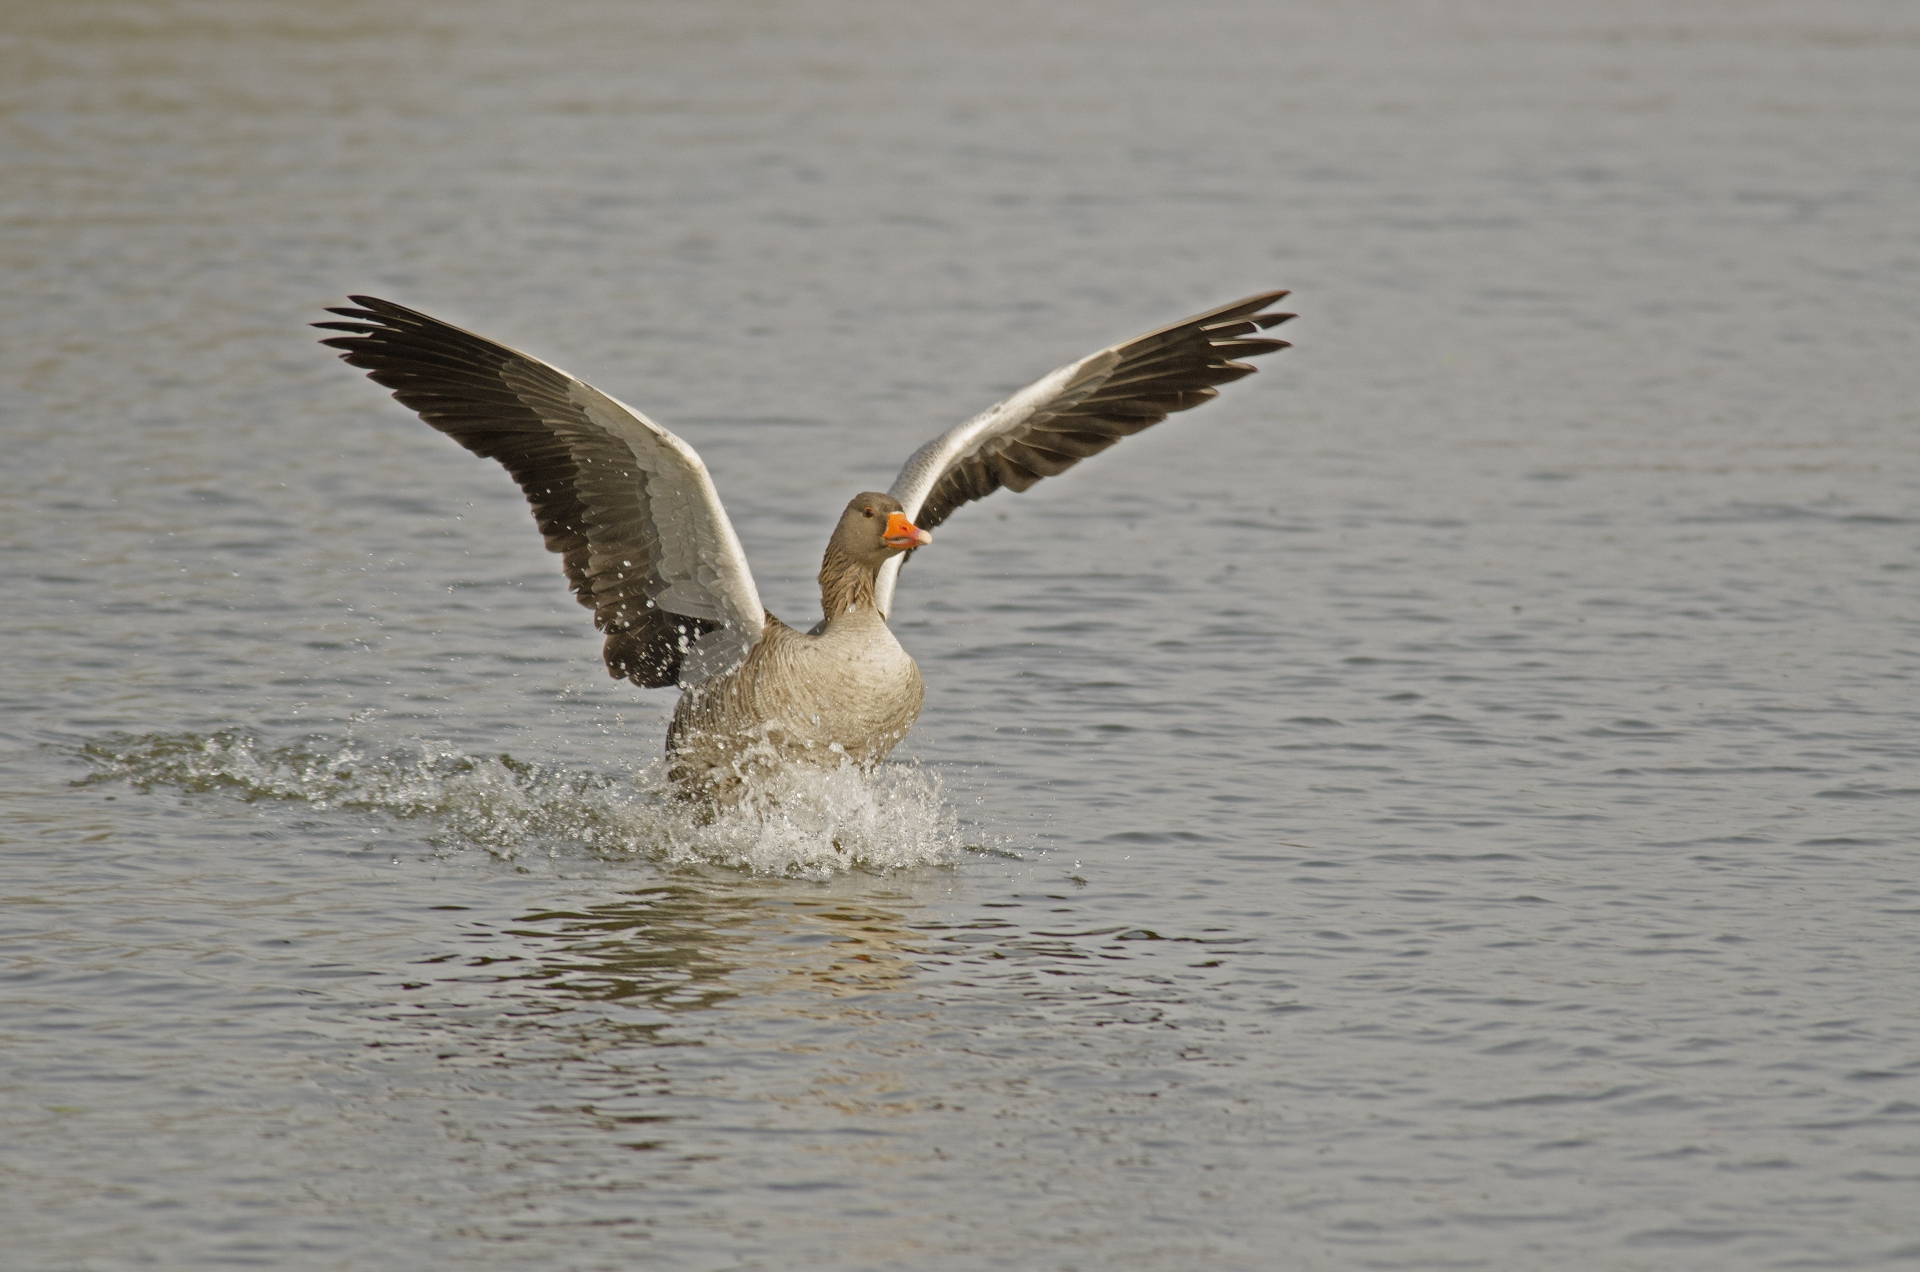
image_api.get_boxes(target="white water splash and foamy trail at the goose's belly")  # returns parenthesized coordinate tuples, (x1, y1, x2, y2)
(81, 730, 968, 878)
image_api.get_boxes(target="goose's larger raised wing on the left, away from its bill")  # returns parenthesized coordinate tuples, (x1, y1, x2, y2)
(315, 296, 766, 688)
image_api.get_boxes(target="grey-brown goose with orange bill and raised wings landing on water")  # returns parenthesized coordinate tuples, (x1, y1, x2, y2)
(315, 290, 1294, 799)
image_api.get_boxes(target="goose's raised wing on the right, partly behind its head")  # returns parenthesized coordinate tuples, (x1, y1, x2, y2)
(874, 292, 1294, 615)
